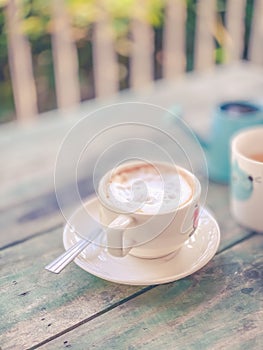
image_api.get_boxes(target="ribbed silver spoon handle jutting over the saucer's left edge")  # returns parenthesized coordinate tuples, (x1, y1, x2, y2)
(45, 239, 91, 273)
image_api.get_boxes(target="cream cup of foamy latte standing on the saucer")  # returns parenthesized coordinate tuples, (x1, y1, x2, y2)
(98, 161, 201, 258)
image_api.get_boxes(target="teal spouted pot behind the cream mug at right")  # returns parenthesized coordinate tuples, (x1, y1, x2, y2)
(197, 101, 263, 183)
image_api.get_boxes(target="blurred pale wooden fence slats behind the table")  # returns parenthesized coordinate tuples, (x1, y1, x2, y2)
(6, 0, 263, 121)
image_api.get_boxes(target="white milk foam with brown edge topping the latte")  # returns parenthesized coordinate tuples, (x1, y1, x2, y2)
(106, 164, 193, 214)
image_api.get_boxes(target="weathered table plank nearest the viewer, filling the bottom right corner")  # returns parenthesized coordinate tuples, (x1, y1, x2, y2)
(37, 236, 263, 350)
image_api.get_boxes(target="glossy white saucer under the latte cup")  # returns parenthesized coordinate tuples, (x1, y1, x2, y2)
(63, 198, 220, 285)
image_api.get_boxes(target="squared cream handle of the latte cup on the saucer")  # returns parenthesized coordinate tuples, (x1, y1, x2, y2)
(106, 215, 133, 257)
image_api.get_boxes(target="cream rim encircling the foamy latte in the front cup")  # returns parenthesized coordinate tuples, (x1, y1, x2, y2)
(97, 161, 201, 217)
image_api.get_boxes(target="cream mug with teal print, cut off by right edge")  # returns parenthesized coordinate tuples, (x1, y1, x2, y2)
(231, 126, 263, 232)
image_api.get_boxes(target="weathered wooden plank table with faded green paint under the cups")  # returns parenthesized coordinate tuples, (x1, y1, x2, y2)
(0, 63, 263, 350)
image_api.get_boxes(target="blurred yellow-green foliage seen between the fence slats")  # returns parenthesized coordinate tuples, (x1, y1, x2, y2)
(0, 0, 253, 123)
